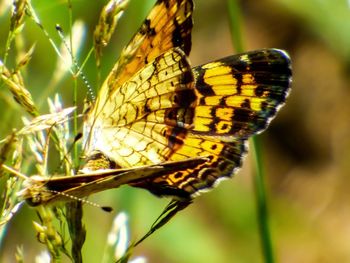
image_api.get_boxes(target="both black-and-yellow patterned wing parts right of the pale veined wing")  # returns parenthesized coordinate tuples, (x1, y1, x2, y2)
(133, 49, 291, 198)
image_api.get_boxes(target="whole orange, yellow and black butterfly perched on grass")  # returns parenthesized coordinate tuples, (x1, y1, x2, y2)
(17, 0, 292, 205)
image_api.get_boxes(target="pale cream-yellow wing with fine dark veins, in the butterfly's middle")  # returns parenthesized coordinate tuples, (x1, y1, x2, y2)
(85, 48, 196, 168)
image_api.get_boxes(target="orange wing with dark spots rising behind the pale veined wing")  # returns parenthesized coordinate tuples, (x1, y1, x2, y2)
(103, 0, 193, 94)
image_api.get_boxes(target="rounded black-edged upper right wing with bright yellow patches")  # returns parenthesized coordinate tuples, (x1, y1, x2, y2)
(192, 49, 291, 137)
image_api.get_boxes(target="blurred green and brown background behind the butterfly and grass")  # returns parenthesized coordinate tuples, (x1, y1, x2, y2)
(0, 0, 350, 263)
